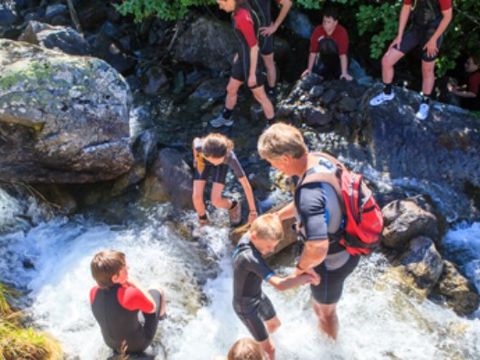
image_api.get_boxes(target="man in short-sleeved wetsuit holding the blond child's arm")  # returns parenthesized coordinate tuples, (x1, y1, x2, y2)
(258, 123, 359, 339)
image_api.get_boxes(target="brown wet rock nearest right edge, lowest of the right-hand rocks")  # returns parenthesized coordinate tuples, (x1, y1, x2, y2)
(435, 261, 480, 315)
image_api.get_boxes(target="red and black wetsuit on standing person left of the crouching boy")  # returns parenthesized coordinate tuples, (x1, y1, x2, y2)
(232, 6, 265, 87)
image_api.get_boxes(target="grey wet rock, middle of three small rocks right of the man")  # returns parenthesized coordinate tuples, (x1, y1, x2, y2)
(399, 236, 443, 295)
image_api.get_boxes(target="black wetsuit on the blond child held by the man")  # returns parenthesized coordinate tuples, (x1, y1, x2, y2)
(233, 234, 275, 341)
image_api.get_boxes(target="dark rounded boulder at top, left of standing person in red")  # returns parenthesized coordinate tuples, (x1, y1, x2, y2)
(174, 17, 236, 71)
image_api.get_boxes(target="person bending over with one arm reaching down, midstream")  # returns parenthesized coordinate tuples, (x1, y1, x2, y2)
(192, 133, 257, 226)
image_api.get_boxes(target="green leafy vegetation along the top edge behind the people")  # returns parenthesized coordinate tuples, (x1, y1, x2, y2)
(117, 0, 480, 76)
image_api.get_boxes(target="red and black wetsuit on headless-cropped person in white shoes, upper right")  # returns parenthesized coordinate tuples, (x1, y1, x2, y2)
(396, 0, 452, 62)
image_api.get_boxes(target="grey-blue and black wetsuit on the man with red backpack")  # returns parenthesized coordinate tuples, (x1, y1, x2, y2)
(295, 158, 359, 304)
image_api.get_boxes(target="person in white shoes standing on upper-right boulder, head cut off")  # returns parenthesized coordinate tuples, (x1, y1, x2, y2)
(370, 0, 453, 120)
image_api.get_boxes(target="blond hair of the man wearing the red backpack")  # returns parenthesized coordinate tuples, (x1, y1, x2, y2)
(257, 123, 308, 159)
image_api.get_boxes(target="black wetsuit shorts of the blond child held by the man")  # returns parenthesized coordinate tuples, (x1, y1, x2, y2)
(233, 294, 276, 341)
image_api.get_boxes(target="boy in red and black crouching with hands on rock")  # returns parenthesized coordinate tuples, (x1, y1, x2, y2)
(302, 7, 352, 81)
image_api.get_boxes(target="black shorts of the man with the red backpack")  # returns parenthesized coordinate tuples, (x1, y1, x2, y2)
(310, 256, 360, 305)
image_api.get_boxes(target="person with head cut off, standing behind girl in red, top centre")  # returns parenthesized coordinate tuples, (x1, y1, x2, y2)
(250, 0, 292, 99)
